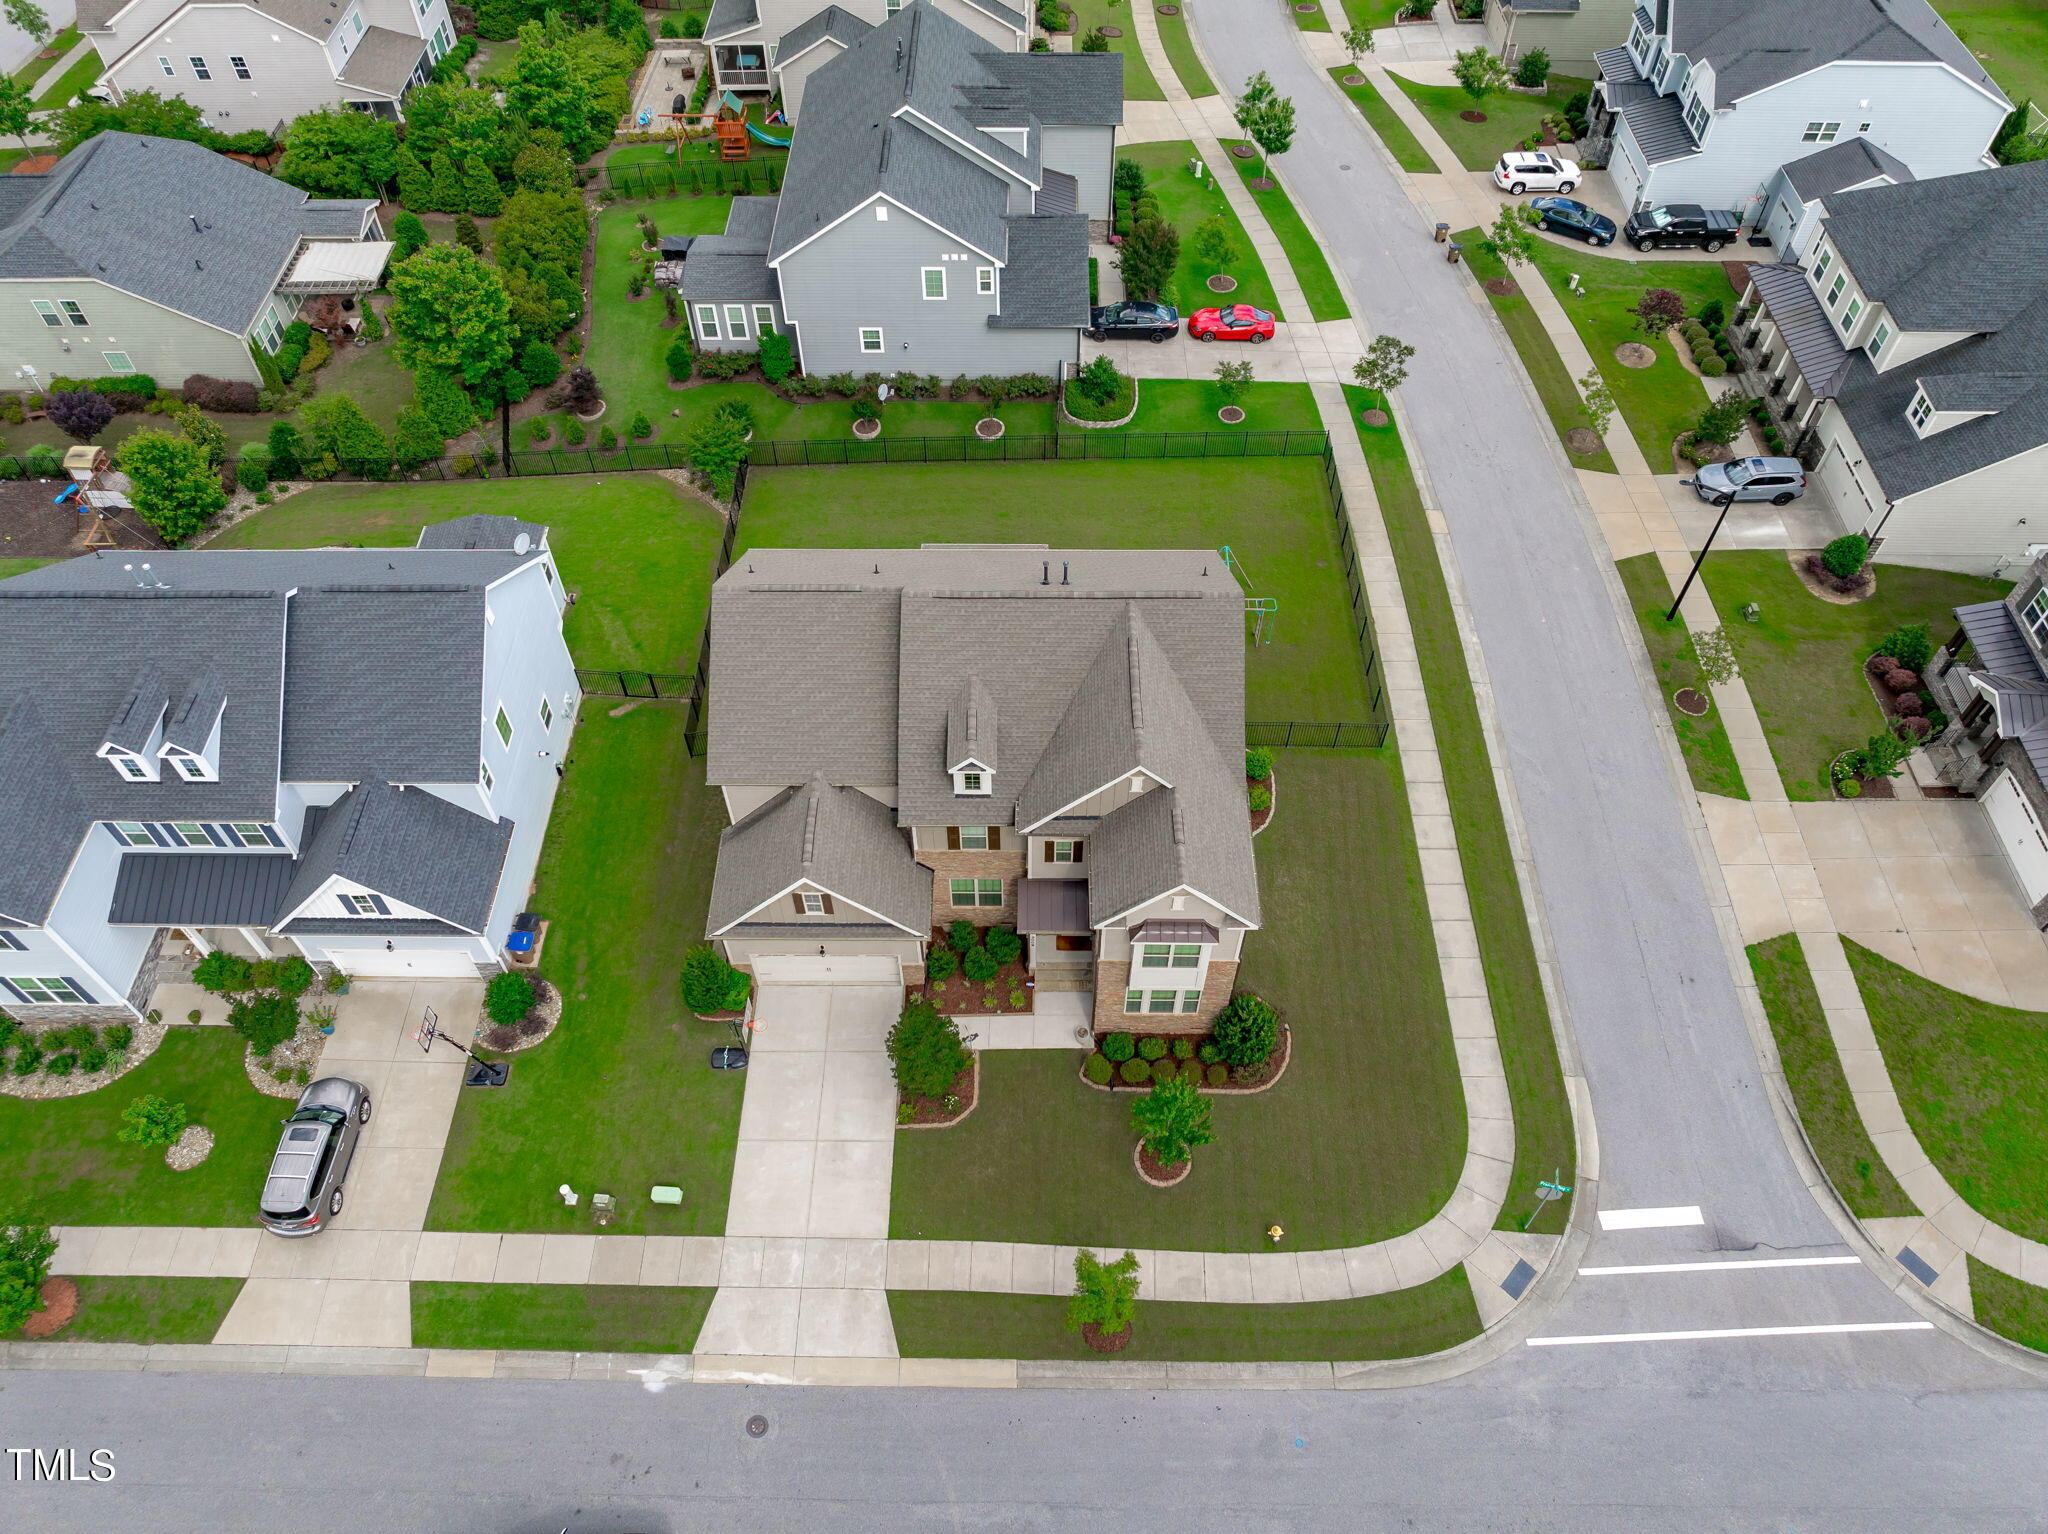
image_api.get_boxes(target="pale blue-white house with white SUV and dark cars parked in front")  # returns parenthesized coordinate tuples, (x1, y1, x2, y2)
(1589, 0, 2013, 223)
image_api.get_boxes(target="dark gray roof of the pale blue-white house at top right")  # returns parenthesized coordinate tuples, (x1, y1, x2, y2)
(1671, 0, 2005, 106)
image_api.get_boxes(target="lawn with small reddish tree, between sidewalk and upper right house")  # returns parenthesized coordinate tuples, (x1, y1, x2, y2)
(1516, 240, 1735, 462)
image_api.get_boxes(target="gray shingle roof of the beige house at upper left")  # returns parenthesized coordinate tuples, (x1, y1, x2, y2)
(0, 133, 375, 336)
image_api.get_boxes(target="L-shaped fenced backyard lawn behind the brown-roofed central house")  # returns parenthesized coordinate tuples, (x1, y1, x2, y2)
(739, 458, 1372, 720)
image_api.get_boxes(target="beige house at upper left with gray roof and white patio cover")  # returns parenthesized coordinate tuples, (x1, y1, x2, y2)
(0, 133, 391, 391)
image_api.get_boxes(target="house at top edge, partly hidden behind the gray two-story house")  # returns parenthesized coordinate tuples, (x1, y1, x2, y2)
(705, 0, 1030, 109)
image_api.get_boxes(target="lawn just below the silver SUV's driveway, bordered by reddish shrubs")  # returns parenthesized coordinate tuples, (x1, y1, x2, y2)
(1702, 551, 2011, 799)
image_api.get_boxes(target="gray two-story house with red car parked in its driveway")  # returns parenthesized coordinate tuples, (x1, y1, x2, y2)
(682, 0, 1124, 377)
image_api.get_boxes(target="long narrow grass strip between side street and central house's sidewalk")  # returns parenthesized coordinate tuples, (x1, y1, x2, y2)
(1346, 395, 1577, 1231)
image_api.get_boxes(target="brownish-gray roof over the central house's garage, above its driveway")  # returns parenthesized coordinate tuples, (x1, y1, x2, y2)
(707, 774, 932, 938)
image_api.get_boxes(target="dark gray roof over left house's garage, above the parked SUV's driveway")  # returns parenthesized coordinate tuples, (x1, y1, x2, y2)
(281, 782, 512, 932)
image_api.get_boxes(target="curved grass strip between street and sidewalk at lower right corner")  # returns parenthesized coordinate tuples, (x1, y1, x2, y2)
(1749, 932, 1919, 1221)
